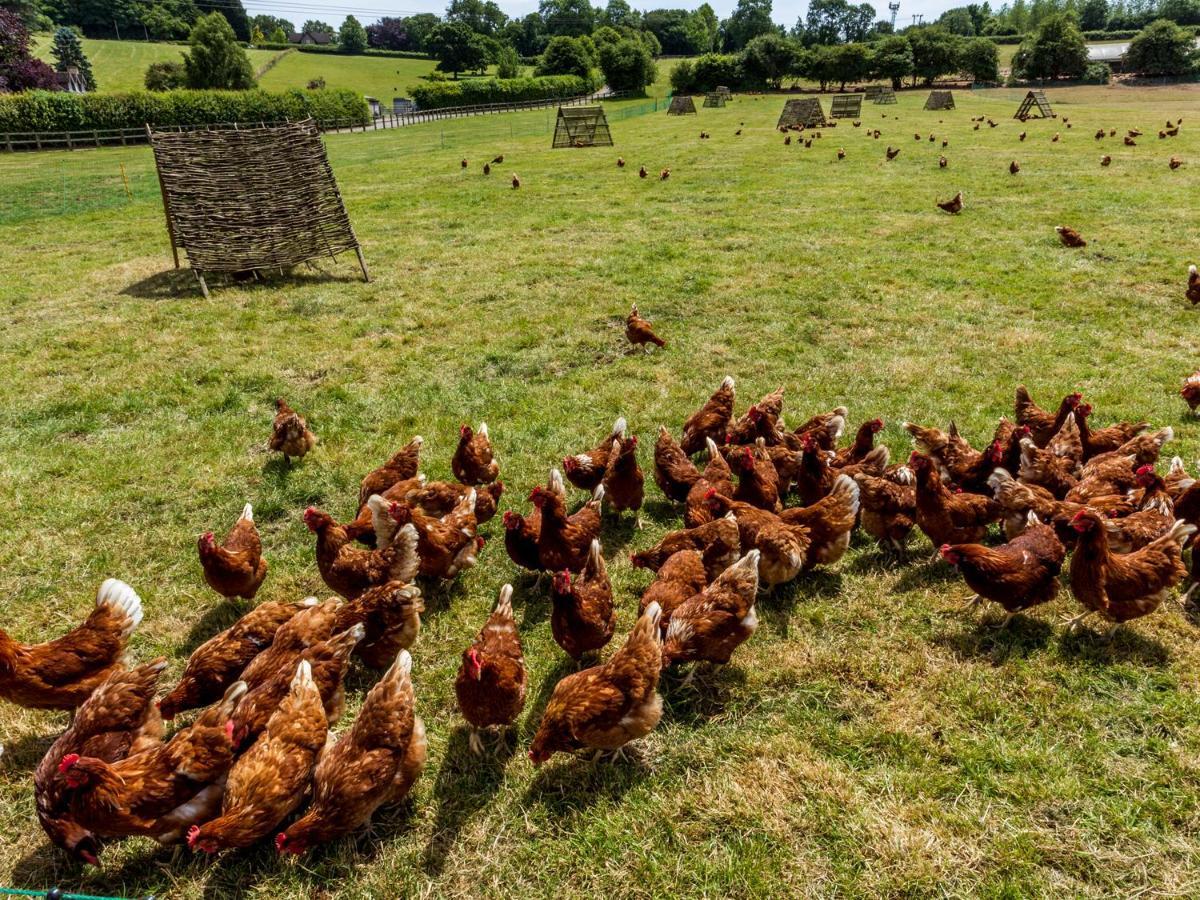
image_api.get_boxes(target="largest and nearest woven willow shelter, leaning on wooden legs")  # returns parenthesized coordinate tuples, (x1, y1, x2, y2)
(146, 119, 360, 296)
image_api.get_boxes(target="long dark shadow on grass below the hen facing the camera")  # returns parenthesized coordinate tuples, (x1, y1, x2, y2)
(421, 726, 517, 876)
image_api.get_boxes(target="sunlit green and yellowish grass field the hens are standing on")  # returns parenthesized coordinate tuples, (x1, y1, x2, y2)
(0, 82, 1200, 898)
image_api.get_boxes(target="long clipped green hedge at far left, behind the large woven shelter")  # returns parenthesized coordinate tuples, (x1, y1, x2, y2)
(0, 88, 371, 133)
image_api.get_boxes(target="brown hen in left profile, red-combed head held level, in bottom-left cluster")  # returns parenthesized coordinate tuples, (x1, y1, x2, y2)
(59, 682, 246, 844)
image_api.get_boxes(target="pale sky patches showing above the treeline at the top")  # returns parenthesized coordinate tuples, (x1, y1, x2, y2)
(245, 0, 966, 28)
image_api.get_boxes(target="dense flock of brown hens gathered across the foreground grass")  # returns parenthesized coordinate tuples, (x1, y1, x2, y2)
(7, 362, 1200, 864)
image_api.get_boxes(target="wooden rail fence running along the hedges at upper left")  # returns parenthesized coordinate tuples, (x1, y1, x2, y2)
(0, 91, 625, 152)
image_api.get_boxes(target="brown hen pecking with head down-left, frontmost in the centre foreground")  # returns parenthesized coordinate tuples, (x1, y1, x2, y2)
(529, 604, 662, 766)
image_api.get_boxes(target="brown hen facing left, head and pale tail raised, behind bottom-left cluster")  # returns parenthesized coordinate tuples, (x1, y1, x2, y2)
(304, 506, 421, 600)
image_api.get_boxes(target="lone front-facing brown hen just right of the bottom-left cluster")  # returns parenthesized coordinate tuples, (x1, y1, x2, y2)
(454, 584, 528, 754)
